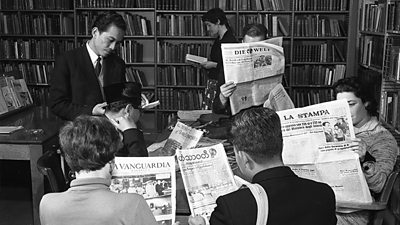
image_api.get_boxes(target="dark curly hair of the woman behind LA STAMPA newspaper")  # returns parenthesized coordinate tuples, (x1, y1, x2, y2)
(333, 77, 378, 116)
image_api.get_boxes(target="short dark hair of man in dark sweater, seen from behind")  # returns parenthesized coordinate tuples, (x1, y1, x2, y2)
(231, 107, 283, 164)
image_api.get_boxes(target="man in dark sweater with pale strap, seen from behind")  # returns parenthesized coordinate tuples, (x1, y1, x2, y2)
(189, 107, 336, 225)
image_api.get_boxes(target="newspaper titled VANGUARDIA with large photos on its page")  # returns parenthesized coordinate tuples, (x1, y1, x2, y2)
(110, 156, 176, 225)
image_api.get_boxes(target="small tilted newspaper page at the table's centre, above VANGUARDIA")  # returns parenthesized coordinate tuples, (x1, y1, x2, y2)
(162, 121, 204, 156)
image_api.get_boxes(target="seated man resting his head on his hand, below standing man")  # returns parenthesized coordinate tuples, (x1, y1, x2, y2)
(104, 82, 148, 157)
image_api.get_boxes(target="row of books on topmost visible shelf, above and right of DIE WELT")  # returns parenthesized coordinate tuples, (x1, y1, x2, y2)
(293, 0, 349, 11)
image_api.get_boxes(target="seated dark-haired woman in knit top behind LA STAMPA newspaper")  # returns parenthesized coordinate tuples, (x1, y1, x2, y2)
(333, 77, 398, 225)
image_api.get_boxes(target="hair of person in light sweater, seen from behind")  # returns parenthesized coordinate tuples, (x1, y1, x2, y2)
(59, 115, 122, 172)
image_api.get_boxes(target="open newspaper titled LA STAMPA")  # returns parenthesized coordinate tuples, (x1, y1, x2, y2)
(277, 100, 372, 206)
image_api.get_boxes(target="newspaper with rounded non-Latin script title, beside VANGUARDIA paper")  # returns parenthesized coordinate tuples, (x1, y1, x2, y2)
(176, 144, 238, 218)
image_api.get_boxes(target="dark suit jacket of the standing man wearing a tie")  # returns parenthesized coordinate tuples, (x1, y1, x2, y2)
(50, 45, 125, 120)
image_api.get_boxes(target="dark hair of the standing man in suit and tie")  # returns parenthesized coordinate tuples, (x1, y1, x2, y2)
(92, 11, 126, 33)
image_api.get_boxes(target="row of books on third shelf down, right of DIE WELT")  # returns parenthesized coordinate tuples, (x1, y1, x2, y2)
(293, 41, 345, 62)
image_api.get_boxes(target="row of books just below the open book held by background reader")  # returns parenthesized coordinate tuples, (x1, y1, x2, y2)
(157, 66, 207, 86)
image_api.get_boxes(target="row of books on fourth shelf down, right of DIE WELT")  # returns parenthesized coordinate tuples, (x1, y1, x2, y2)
(290, 65, 346, 85)
